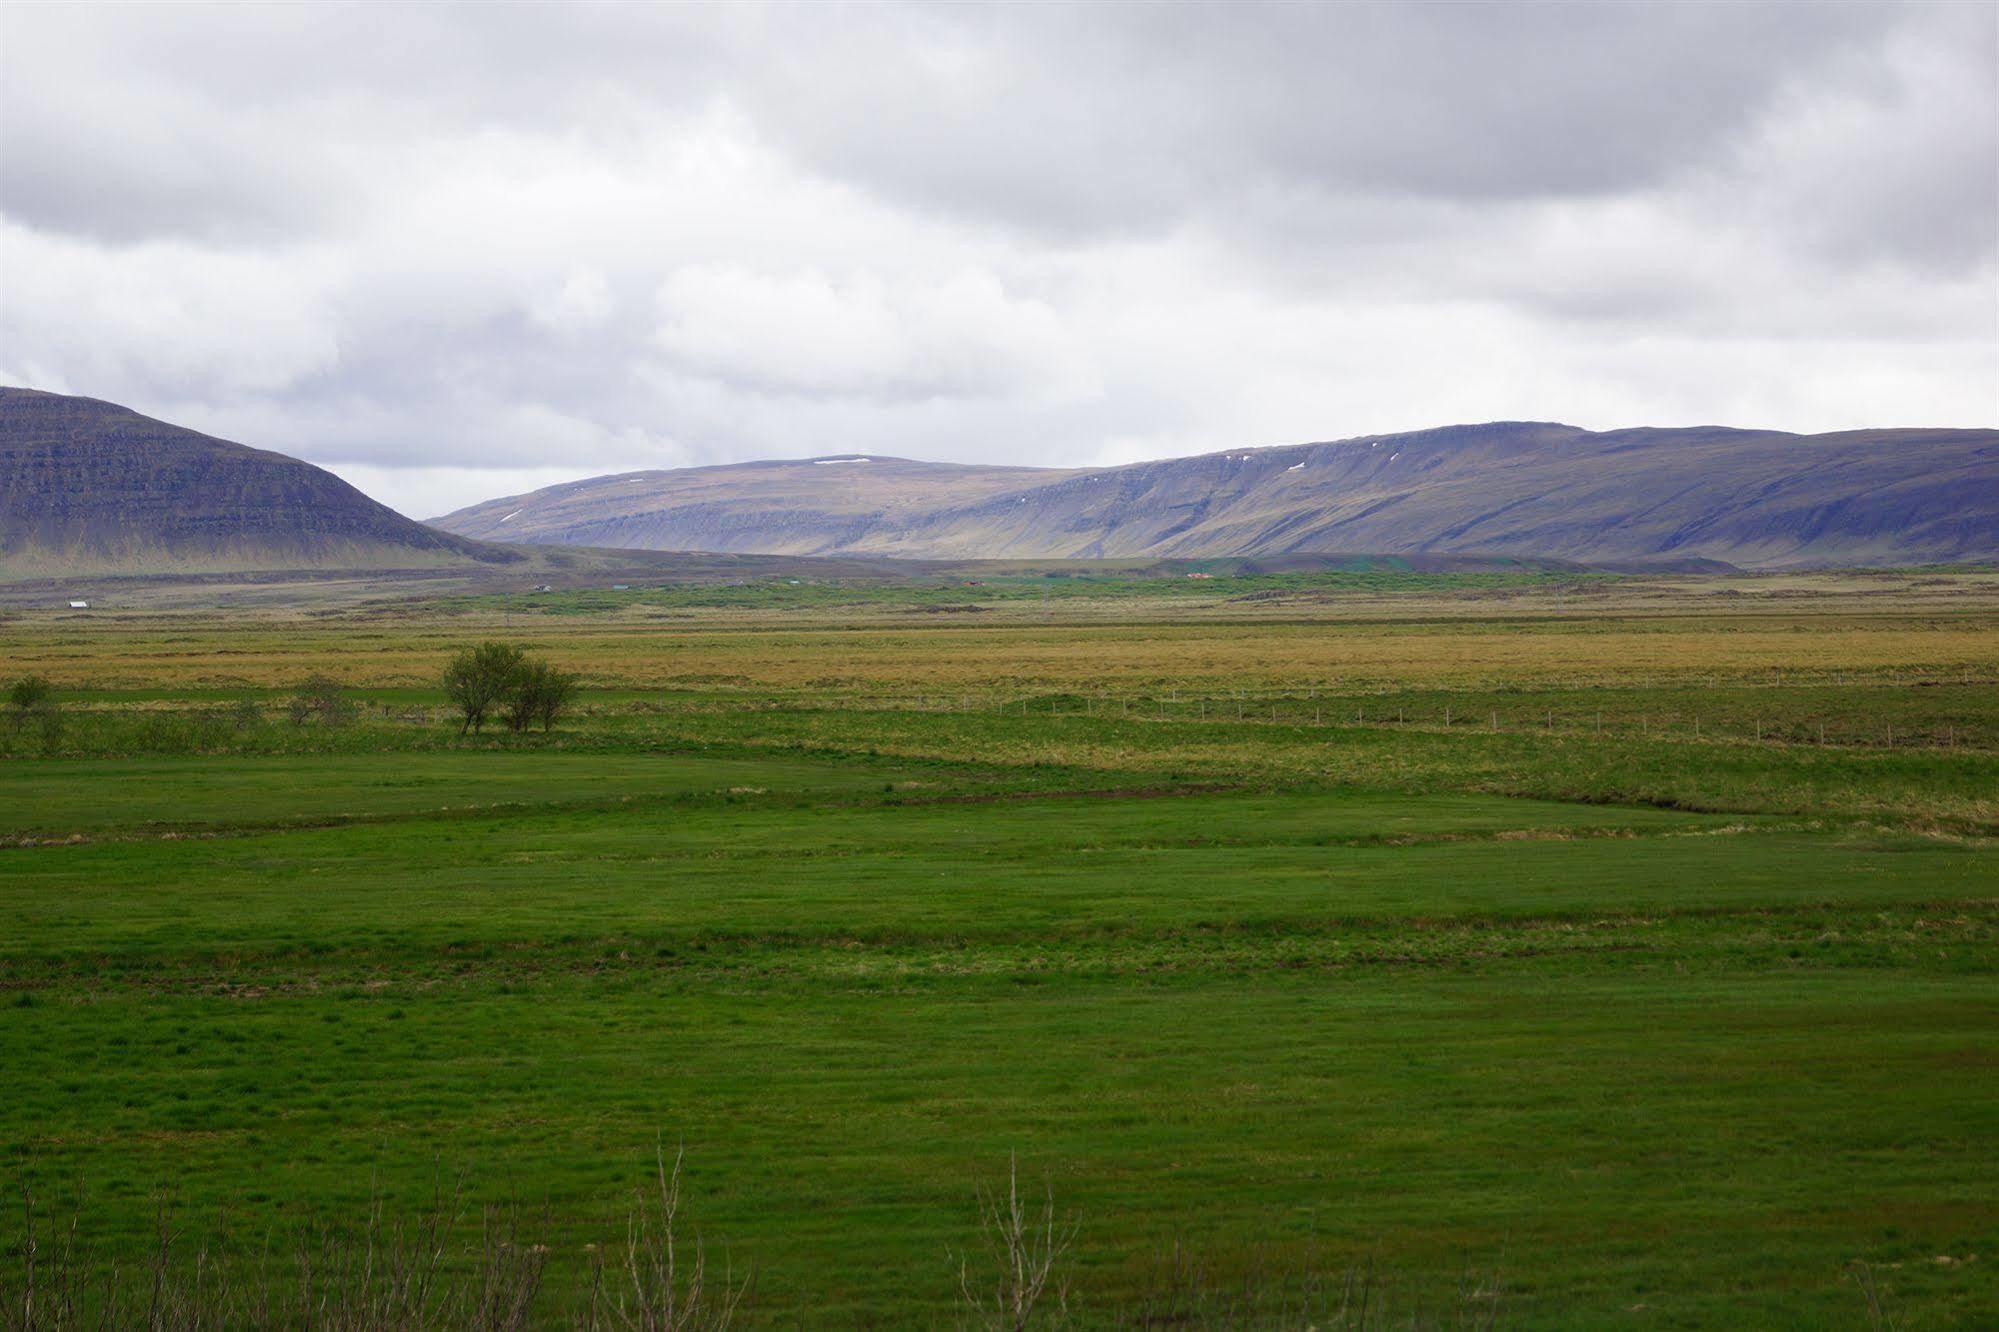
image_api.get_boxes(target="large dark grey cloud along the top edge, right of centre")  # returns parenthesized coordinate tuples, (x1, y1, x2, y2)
(739, 0, 1893, 228)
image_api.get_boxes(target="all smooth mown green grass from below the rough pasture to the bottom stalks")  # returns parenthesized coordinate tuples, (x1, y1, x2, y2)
(0, 754, 1999, 1326)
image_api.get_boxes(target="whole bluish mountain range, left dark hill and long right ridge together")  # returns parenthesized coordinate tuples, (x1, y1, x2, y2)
(0, 388, 1999, 580)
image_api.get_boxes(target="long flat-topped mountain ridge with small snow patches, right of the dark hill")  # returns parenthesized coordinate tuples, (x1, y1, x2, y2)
(432, 422, 1999, 568)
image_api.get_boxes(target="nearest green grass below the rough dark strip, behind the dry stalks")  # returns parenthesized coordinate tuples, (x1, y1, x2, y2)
(6, 962, 1999, 1326)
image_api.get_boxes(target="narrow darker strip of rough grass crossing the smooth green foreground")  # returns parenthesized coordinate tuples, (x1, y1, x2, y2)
(0, 896, 1999, 992)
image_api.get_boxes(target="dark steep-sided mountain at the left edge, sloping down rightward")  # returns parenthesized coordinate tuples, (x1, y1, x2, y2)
(0, 388, 518, 578)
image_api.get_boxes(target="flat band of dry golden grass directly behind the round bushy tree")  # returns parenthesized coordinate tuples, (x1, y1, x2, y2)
(0, 614, 1999, 692)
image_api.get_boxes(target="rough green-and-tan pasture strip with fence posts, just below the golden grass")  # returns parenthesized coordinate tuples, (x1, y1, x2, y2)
(11, 684, 1999, 840)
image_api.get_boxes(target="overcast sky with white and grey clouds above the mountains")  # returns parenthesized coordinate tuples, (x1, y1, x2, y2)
(0, 0, 1999, 516)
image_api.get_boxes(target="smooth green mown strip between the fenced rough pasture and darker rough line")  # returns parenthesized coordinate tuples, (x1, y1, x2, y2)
(0, 796, 1999, 960)
